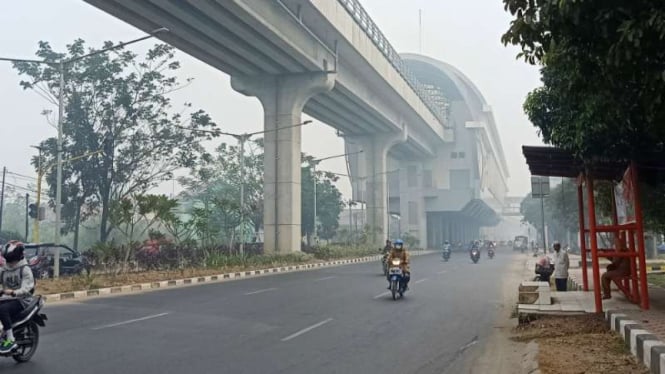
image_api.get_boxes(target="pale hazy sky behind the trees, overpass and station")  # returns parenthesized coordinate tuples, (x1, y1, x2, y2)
(0, 0, 541, 202)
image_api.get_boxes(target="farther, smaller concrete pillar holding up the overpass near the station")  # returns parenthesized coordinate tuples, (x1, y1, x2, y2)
(354, 125, 408, 246)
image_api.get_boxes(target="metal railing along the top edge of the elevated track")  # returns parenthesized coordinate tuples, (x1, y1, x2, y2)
(337, 0, 448, 126)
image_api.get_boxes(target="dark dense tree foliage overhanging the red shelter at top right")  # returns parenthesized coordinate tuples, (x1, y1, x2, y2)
(502, 0, 665, 160)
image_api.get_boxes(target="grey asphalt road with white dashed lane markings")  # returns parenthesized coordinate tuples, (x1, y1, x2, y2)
(0, 250, 513, 374)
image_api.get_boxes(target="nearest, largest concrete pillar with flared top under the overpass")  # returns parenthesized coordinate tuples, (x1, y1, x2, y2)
(231, 73, 335, 253)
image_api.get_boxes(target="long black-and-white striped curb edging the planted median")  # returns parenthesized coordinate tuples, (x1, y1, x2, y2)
(42, 251, 439, 302)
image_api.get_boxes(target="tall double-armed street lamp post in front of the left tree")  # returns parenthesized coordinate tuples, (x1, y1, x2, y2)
(0, 27, 168, 278)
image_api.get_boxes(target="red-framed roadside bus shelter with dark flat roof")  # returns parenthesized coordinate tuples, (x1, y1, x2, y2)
(522, 146, 652, 313)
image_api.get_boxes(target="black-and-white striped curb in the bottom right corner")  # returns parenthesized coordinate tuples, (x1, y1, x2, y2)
(605, 310, 665, 374)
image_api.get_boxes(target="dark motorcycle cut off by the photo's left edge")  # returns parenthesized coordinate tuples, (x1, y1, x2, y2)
(0, 296, 48, 363)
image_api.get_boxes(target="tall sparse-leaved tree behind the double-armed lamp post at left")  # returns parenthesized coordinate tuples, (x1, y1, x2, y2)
(14, 39, 216, 241)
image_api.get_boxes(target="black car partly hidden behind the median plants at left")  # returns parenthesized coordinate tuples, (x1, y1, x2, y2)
(25, 243, 85, 278)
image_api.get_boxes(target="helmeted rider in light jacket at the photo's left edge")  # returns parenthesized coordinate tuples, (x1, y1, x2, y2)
(0, 240, 35, 354)
